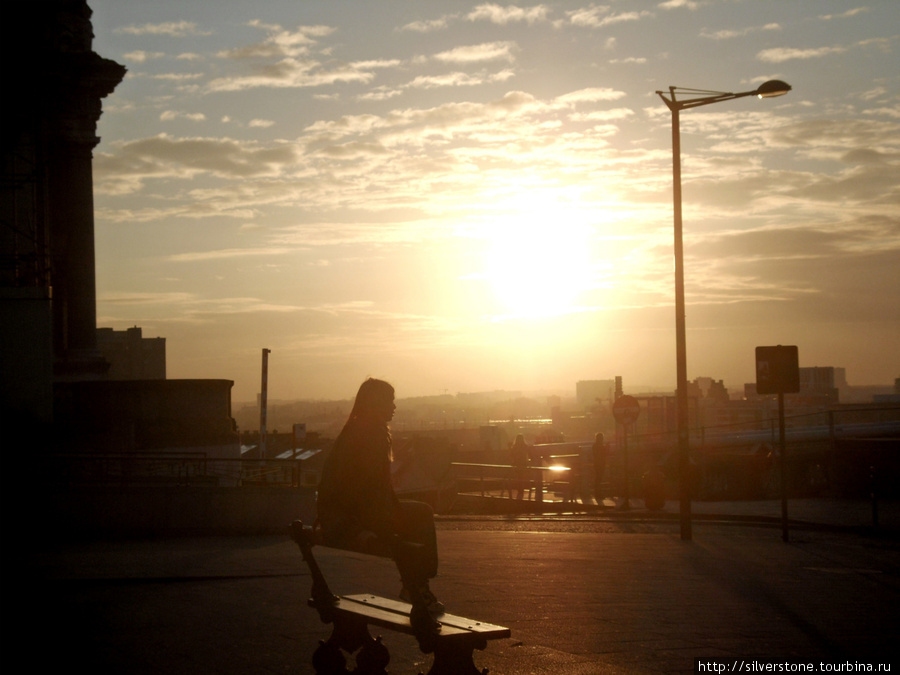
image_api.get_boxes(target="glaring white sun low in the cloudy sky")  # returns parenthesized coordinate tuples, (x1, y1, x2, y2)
(483, 191, 593, 318)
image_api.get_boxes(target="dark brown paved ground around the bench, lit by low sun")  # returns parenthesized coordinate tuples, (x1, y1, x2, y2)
(14, 501, 900, 675)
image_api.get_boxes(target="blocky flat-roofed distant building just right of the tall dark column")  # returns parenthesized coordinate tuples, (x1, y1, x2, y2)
(97, 326, 166, 380)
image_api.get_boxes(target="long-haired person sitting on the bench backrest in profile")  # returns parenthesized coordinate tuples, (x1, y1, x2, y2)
(316, 378, 444, 629)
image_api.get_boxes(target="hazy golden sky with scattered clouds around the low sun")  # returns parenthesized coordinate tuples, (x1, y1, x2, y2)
(89, 0, 900, 400)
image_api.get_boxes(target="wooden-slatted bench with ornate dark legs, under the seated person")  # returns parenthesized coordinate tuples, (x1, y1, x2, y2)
(291, 520, 510, 675)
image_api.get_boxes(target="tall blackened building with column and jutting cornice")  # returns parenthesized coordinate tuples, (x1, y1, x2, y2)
(0, 0, 125, 420)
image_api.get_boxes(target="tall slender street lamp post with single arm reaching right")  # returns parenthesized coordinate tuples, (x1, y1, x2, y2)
(656, 80, 791, 541)
